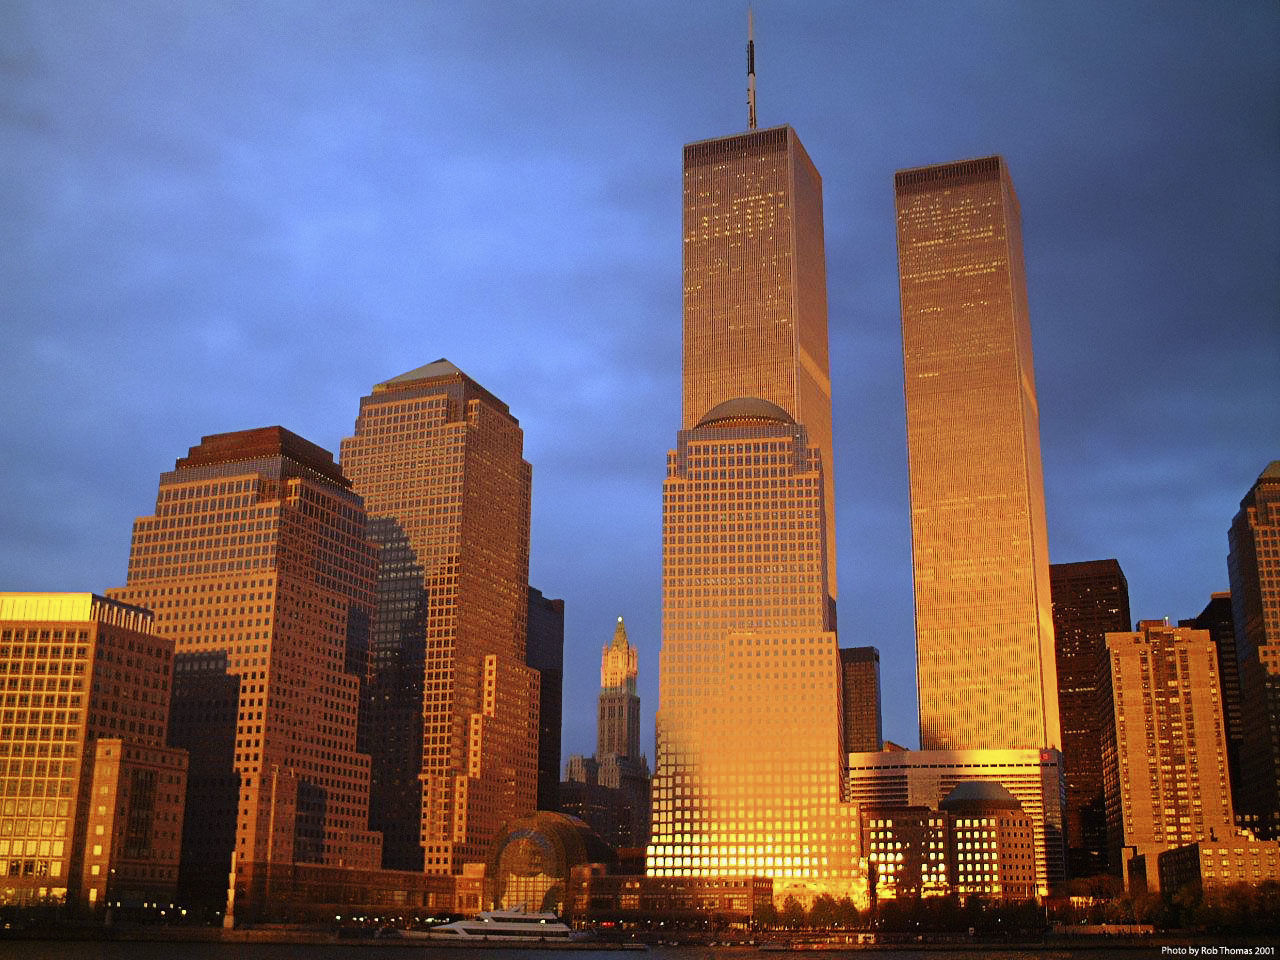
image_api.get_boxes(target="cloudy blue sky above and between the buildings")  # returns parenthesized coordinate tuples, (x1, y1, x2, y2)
(0, 0, 1280, 758)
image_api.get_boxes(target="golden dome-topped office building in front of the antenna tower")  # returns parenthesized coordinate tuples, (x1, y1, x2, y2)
(646, 399, 858, 896)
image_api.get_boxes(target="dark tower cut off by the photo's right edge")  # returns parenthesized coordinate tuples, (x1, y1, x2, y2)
(1228, 460, 1280, 840)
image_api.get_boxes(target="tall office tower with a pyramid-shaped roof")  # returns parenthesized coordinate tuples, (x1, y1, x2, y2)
(342, 360, 539, 874)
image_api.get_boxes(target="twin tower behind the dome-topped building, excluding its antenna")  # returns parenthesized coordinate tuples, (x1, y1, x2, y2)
(681, 127, 837, 598)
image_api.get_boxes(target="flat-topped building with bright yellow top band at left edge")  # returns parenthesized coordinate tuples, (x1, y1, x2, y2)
(0, 593, 187, 909)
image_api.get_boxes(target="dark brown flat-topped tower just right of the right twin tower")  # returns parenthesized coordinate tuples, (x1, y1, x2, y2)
(1048, 559, 1133, 877)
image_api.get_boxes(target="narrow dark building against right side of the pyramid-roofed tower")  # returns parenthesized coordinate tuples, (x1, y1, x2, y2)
(525, 586, 564, 812)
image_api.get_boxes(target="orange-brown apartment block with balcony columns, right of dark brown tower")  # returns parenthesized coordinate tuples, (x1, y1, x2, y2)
(1103, 620, 1235, 882)
